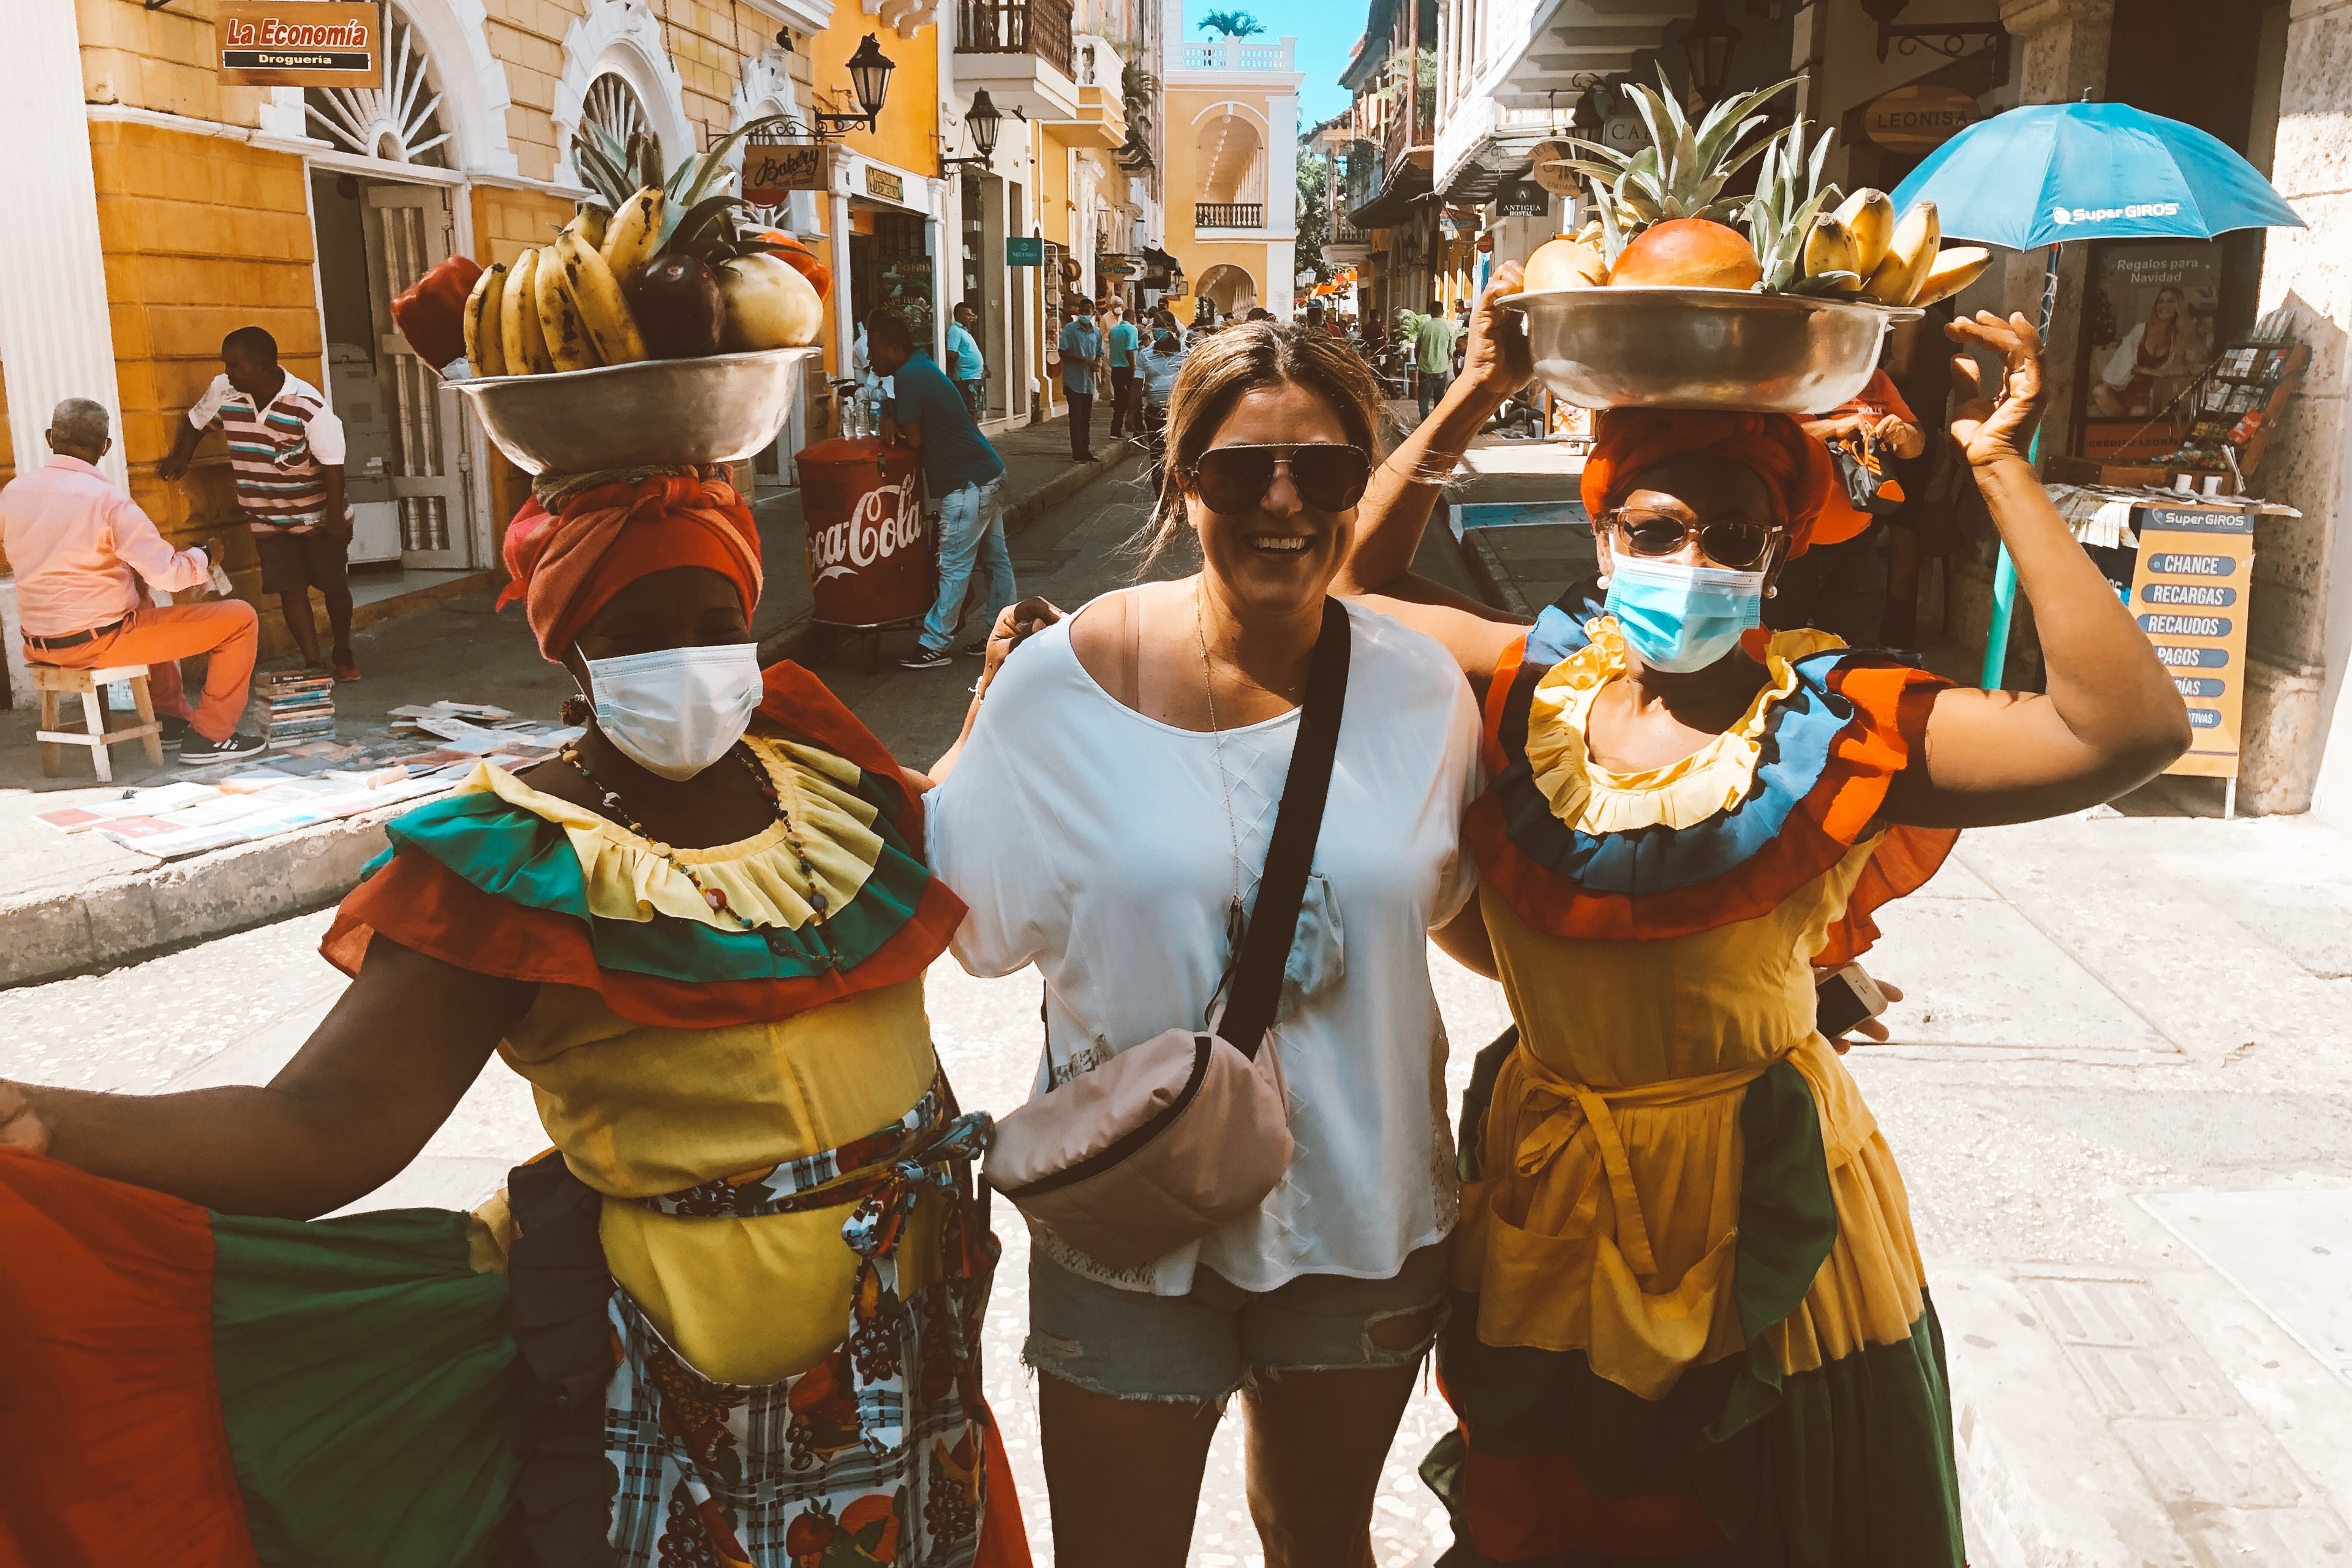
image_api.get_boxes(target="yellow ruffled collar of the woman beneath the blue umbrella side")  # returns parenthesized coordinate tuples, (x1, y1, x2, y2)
(1526, 616, 1846, 835)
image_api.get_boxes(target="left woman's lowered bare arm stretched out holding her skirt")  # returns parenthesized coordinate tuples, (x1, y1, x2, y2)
(0, 936, 538, 1220)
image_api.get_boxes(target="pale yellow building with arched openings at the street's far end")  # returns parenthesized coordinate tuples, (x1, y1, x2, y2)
(1164, 0, 1305, 320)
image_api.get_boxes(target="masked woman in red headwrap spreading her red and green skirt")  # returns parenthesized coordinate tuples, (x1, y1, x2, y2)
(0, 472, 1028, 1568)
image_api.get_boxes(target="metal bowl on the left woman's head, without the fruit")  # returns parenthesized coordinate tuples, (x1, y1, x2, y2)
(449, 348, 818, 475)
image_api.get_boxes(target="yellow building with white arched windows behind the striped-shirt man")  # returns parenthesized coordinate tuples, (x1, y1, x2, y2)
(0, 0, 957, 672)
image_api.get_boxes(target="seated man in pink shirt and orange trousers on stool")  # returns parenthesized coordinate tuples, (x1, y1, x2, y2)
(0, 398, 263, 766)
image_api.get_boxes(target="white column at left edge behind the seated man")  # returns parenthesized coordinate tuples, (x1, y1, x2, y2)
(0, 2, 129, 489)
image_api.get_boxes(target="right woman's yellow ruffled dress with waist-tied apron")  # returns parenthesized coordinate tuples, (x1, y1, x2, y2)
(1425, 606, 1962, 1568)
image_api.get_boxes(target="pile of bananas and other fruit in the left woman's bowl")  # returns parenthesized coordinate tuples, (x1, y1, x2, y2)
(466, 123, 823, 376)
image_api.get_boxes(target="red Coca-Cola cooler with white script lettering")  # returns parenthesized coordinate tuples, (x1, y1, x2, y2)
(797, 435, 938, 673)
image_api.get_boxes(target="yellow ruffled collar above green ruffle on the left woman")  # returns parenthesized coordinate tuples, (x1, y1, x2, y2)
(459, 736, 882, 931)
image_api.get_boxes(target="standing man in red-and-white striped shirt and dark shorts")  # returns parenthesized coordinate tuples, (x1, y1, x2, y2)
(155, 326, 360, 682)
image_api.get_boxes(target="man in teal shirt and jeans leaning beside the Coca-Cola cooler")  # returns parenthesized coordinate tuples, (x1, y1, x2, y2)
(865, 311, 1016, 670)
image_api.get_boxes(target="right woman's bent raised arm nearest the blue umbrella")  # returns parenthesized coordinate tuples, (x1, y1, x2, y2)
(1889, 311, 2190, 827)
